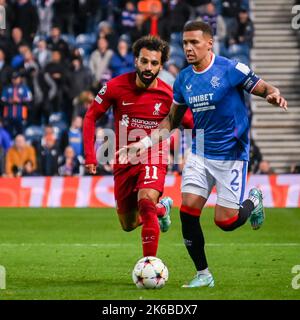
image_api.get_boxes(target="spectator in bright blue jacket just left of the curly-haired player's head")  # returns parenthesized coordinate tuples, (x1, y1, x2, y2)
(109, 38, 134, 78)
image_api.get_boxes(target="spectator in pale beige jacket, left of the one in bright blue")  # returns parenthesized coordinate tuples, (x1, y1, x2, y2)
(89, 37, 114, 90)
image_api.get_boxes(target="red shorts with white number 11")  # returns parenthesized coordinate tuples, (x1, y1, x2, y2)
(114, 164, 167, 214)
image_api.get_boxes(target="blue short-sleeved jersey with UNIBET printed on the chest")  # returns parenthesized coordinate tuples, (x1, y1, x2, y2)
(173, 55, 260, 160)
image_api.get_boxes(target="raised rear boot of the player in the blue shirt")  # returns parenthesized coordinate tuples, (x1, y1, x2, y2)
(249, 188, 265, 230)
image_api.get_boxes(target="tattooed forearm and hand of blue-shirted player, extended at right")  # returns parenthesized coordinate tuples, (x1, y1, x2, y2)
(251, 80, 287, 110)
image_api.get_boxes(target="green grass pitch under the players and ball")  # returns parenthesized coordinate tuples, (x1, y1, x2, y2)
(0, 208, 300, 300)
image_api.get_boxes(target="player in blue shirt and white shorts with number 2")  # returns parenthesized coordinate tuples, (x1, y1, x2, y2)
(118, 21, 287, 288)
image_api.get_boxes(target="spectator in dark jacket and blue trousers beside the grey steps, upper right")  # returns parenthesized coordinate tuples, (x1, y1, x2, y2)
(228, 8, 254, 65)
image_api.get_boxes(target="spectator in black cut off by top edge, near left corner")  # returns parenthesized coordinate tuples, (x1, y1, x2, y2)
(13, 0, 39, 44)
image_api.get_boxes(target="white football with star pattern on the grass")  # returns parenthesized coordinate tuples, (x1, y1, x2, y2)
(132, 257, 169, 289)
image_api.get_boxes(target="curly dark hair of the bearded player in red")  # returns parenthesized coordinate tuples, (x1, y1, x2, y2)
(132, 35, 170, 64)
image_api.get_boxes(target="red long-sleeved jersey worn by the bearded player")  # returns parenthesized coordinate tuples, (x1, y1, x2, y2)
(83, 72, 191, 164)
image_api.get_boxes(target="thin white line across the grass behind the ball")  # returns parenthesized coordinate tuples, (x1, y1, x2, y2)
(0, 242, 300, 248)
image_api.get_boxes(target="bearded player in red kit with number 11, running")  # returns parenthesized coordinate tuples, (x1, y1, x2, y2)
(83, 36, 192, 256)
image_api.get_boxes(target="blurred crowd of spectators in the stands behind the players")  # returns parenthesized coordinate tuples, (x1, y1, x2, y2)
(0, 0, 278, 177)
